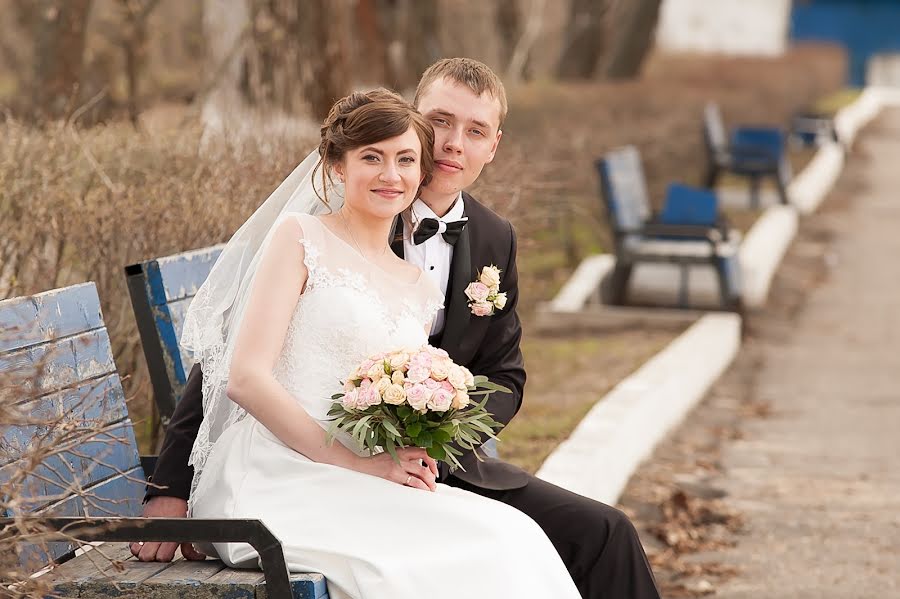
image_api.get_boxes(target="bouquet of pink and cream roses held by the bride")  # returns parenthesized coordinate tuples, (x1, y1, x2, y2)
(328, 345, 509, 470)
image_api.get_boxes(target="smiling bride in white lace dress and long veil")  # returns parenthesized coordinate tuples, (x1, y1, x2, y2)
(182, 89, 579, 599)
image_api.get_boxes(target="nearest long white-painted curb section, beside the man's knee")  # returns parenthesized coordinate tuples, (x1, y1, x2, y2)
(537, 313, 741, 504)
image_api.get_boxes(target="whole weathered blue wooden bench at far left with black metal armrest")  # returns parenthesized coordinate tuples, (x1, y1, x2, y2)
(0, 283, 327, 599)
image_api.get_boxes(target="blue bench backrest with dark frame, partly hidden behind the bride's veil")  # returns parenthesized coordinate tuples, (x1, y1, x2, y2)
(125, 245, 224, 424)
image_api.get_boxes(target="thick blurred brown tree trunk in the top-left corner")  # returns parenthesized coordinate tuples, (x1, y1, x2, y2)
(32, 0, 91, 118)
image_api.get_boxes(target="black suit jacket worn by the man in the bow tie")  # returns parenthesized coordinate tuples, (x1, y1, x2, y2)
(147, 193, 529, 499)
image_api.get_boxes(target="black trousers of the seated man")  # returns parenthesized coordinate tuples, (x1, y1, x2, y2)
(445, 476, 660, 599)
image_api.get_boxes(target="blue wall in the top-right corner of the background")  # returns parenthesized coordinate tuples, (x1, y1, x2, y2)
(791, 0, 900, 86)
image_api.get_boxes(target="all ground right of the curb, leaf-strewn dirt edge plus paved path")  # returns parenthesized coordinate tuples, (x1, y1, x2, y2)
(620, 111, 900, 599)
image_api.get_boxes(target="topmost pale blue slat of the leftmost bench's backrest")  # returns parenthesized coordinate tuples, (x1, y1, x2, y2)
(0, 283, 103, 353)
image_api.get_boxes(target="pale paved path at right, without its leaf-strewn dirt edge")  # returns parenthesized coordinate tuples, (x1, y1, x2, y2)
(717, 111, 900, 599)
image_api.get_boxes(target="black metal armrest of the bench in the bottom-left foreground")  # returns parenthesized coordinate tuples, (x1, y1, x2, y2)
(0, 516, 292, 599)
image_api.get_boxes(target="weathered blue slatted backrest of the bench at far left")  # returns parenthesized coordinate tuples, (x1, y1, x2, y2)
(0, 283, 145, 565)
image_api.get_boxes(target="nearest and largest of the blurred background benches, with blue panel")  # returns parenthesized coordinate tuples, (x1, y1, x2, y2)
(596, 146, 740, 310)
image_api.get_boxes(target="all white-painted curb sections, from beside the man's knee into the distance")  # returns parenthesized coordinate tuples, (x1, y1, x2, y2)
(537, 88, 900, 504)
